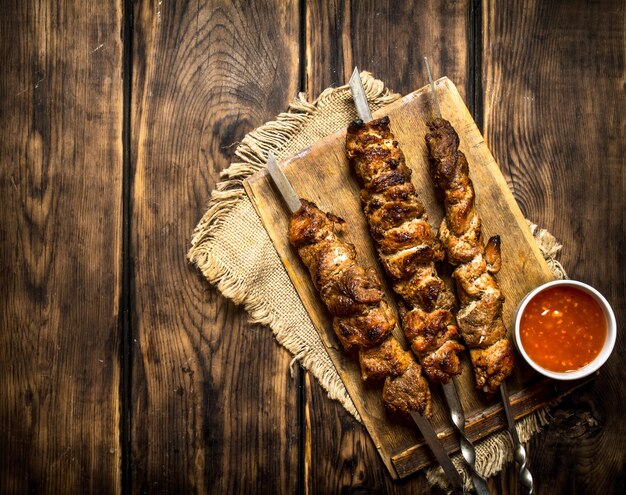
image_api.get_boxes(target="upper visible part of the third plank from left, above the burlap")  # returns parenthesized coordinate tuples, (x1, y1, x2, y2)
(306, 0, 471, 102)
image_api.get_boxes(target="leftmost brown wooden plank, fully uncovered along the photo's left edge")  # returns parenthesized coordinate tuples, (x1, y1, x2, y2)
(0, 1, 123, 494)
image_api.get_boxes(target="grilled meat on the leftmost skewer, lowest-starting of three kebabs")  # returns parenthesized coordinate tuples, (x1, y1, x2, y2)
(289, 199, 432, 417)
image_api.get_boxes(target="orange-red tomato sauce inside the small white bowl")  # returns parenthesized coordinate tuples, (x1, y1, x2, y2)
(520, 287, 607, 372)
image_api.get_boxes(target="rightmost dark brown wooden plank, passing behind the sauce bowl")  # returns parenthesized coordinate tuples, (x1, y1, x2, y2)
(483, 0, 626, 494)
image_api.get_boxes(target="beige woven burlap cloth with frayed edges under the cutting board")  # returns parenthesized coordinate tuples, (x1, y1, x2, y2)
(188, 72, 565, 486)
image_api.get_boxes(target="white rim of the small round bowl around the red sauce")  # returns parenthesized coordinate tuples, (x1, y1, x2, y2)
(514, 279, 617, 380)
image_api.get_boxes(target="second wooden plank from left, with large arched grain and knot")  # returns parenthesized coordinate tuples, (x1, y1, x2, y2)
(131, 1, 299, 493)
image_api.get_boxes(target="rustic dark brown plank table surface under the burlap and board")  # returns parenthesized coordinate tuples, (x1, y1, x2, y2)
(0, 0, 626, 494)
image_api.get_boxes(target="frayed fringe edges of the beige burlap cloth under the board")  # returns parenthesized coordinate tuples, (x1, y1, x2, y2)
(187, 72, 566, 489)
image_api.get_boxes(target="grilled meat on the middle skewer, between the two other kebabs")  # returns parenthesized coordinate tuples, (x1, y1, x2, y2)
(346, 117, 464, 383)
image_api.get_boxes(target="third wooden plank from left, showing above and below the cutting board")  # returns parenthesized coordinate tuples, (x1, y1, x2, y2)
(305, 0, 471, 494)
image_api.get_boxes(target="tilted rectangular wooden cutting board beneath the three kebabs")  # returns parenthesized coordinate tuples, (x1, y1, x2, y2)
(244, 78, 577, 478)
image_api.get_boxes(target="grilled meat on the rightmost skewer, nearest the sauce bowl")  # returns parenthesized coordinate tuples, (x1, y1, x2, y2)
(426, 118, 514, 393)
